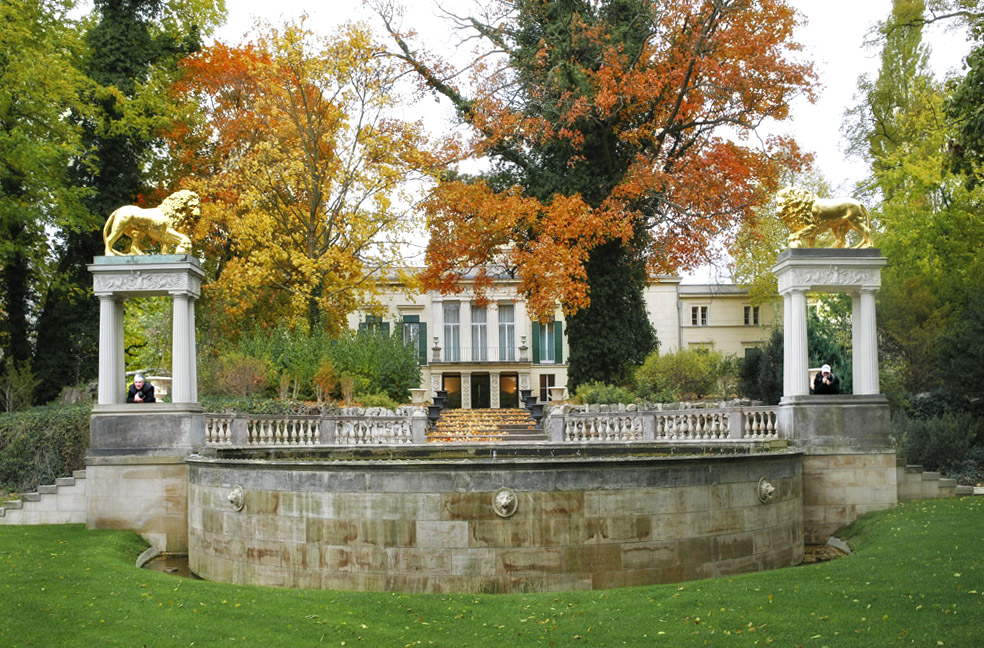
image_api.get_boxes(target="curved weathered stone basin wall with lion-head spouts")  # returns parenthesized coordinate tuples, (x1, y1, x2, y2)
(189, 448, 803, 593)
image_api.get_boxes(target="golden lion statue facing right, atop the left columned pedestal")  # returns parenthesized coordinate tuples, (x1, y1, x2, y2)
(103, 189, 202, 256)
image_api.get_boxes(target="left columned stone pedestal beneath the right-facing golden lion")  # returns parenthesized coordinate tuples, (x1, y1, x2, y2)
(86, 255, 205, 552)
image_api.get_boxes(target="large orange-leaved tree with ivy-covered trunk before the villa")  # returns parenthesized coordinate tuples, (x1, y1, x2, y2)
(377, 0, 814, 386)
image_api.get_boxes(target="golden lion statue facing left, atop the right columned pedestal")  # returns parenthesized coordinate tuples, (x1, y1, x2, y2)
(776, 187, 874, 248)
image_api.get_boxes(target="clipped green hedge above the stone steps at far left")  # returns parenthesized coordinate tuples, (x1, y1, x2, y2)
(0, 404, 92, 491)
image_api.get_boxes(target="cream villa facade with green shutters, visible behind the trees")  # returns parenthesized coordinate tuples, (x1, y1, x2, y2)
(349, 277, 775, 409)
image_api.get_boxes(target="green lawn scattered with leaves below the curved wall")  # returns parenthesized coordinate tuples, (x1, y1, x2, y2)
(0, 498, 984, 648)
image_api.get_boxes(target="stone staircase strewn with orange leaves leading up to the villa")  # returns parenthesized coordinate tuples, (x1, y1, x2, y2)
(427, 409, 547, 443)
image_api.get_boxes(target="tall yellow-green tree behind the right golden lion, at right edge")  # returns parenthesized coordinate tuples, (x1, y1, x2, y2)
(846, 0, 984, 393)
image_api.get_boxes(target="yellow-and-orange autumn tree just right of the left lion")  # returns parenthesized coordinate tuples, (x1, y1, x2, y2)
(171, 21, 438, 333)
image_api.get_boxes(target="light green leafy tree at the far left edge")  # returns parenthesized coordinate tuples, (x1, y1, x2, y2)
(0, 0, 93, 370)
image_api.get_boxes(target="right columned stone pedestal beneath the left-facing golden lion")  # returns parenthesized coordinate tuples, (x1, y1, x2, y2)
(773, 249, 898, 543)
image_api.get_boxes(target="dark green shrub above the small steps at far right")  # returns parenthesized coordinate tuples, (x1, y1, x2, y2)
(892, 412, 984, 472)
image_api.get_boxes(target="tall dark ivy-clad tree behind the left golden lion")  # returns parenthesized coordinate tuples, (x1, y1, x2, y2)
(35, 0, 225, 400)
